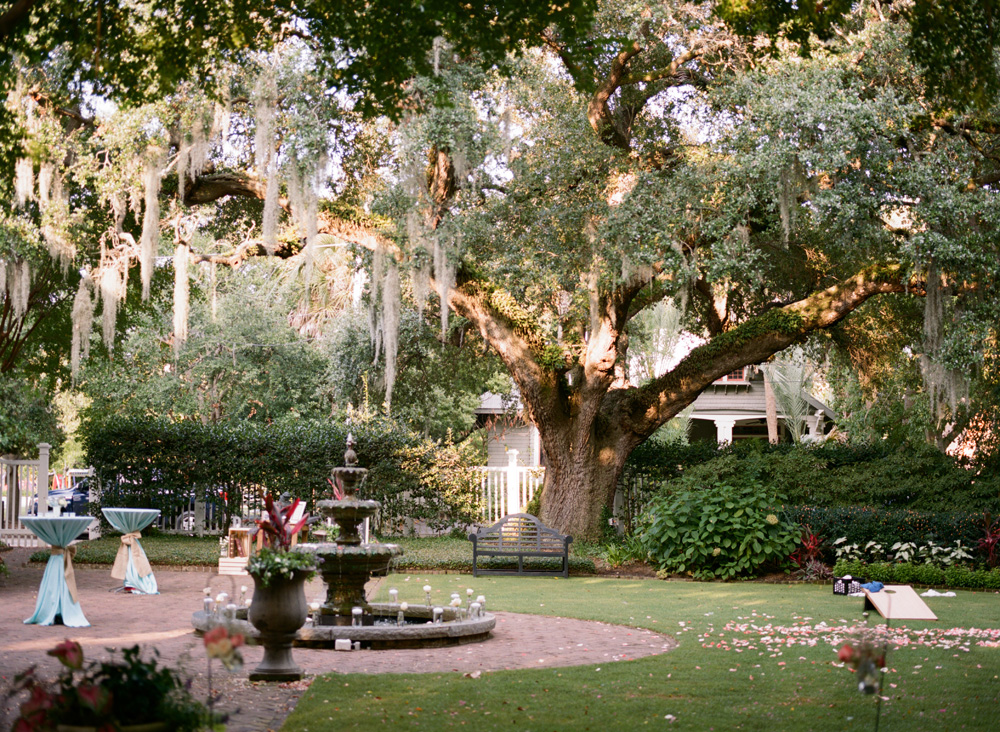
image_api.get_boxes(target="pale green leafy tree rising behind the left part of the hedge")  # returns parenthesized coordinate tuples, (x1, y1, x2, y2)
(79, 260, 326, 424)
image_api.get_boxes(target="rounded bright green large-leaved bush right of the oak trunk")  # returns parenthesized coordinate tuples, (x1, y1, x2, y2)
(640, 483, 799, 578)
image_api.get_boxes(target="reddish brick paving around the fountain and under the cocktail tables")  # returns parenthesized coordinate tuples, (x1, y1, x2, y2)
(0, 550, 675, 732)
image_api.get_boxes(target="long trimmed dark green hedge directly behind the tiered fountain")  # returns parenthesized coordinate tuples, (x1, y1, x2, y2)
(83, 415, 478, 529)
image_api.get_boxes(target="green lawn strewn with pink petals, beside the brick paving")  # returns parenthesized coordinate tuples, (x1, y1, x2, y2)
(283, 572, 1000, 732)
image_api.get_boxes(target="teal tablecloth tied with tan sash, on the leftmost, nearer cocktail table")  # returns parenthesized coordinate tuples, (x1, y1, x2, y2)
(21, 516, 94, 628)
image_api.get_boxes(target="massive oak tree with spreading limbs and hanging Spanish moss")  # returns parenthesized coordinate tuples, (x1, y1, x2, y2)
(5, 2, 1000, 536)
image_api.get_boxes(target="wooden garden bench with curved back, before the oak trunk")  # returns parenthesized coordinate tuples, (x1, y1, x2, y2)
(469, 513, 573, 577)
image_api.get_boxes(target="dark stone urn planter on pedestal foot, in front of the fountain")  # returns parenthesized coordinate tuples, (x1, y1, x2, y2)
(247, 571, 311, 681)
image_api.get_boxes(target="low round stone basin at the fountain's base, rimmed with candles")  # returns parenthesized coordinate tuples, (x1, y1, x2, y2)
(191, 602, 496, 650)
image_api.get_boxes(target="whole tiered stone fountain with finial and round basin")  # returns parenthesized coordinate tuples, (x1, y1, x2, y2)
(192, 435, 496, 649)
